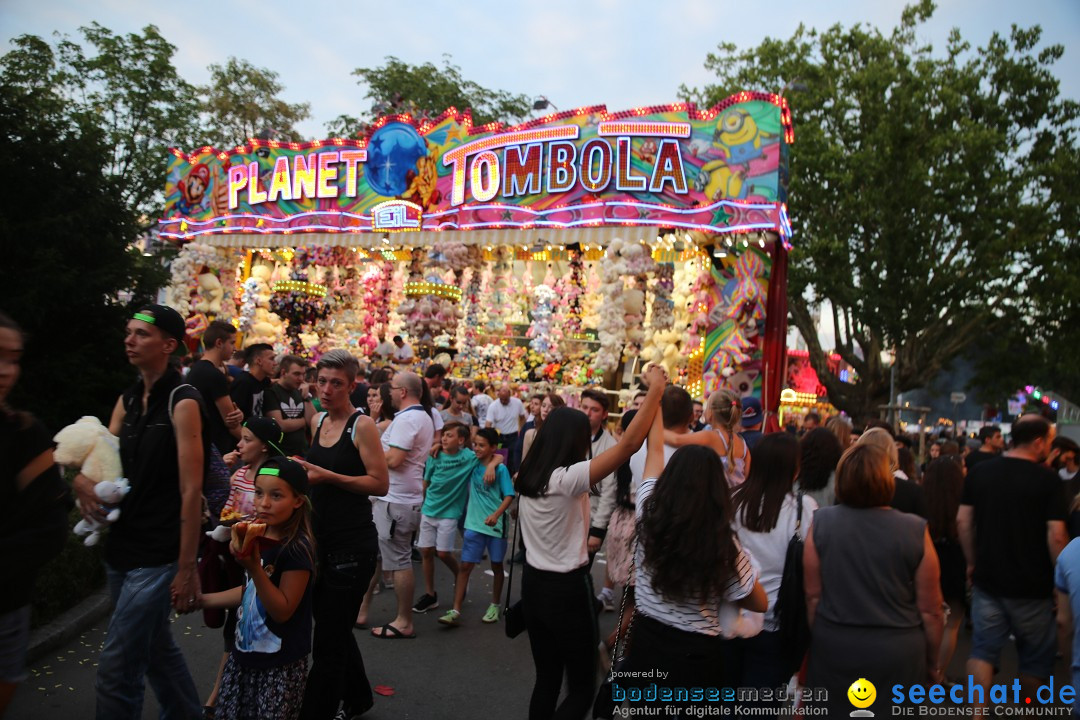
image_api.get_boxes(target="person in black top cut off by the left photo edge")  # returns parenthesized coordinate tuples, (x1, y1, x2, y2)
(0, 313, 71, 717)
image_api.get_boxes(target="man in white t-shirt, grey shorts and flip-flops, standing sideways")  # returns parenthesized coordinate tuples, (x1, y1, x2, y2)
(372, 372, 435, 638)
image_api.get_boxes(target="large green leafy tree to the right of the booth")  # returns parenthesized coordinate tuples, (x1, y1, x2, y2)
(681, 0, 1078, 415)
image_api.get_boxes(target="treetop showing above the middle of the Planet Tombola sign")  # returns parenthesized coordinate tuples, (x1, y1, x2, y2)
(326, 55, 532, 137)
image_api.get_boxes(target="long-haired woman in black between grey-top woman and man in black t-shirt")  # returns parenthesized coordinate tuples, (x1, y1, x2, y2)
(922, 458, 968, 671)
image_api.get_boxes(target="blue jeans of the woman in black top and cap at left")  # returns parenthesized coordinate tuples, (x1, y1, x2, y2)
(96, 562, 202, 720)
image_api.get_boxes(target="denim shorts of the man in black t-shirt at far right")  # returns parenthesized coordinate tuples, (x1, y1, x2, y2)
(971, 587, 1057, 678)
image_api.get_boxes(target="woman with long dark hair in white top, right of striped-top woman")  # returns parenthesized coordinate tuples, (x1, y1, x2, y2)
(724, 430, 812, 688)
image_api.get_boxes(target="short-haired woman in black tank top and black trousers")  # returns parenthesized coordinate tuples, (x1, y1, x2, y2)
(300, 350, 390, 720)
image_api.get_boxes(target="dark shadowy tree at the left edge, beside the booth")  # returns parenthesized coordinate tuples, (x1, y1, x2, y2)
(0, 37, 164, 429)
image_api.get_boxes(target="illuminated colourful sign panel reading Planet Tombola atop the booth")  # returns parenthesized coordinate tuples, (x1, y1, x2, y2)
(161, 93, 794, 239)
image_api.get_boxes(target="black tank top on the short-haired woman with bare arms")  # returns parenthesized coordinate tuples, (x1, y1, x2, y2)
(306, 410, 376, 553)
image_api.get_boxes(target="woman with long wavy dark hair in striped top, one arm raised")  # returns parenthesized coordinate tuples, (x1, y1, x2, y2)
(627, 399, 767, 714)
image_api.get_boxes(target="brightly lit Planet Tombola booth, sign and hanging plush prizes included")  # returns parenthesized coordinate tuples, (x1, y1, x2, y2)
(160, 93, 794, 425)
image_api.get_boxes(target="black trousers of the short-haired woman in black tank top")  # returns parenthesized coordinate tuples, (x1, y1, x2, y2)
(300, 546, 376, 720)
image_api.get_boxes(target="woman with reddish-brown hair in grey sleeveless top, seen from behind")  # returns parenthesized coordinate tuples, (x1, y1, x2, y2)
(804, 443, 944, 715)
